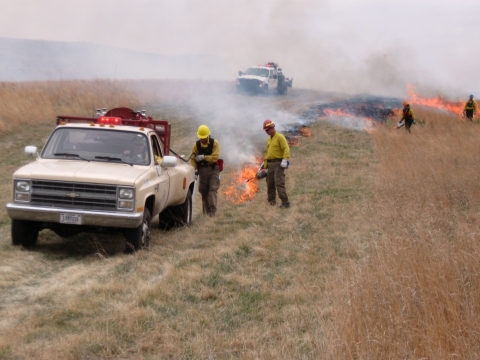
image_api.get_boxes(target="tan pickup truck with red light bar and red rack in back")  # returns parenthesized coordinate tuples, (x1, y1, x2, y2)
(6, 108, 195, 251)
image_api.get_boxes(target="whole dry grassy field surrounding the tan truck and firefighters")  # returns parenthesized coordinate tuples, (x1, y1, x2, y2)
(0, 82, 480, 359)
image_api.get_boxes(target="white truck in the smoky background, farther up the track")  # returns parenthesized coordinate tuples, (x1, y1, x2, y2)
(236, 62, 293, 95)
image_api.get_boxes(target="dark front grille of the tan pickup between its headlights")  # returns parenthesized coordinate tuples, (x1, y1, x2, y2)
(31, 180, 117, 210)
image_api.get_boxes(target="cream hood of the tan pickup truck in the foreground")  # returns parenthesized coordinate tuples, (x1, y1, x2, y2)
(13, 159, 148, 185)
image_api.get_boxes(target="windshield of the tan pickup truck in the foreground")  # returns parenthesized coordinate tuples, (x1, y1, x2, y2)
(42, 127, 150, 165)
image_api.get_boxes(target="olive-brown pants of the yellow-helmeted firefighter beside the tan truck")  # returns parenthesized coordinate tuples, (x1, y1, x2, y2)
(198, 165, 220, 216)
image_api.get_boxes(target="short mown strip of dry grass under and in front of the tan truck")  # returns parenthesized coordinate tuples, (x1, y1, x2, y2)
(0, 79, 376, 359)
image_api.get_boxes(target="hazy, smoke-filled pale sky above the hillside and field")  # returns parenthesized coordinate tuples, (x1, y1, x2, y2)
(0, 0, 480, 97)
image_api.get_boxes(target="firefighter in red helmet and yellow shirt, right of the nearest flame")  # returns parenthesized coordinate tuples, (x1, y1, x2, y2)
(262, 120, 290, 208)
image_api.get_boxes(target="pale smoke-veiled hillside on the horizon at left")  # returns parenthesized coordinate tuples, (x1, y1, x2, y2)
(0, 38, 227, 81)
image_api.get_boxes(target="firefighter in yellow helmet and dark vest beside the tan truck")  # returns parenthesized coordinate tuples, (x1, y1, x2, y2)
(190, 125, 220, 216)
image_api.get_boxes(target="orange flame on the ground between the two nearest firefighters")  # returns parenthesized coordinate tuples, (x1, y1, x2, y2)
(223, 164, 258, 204)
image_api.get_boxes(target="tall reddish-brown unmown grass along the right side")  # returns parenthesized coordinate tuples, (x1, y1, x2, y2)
(330, 109, 480, 359)
